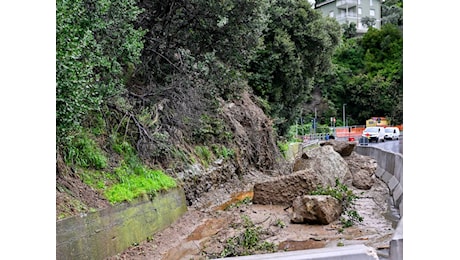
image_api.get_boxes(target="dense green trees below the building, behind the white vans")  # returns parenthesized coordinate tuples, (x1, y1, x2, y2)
(315, 20, 403, 124)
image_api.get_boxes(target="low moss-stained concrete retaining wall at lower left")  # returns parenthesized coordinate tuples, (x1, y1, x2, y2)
(56, 188, 187, 260)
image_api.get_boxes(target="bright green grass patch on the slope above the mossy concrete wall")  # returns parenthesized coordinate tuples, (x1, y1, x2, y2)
(66, 134, 177, 204)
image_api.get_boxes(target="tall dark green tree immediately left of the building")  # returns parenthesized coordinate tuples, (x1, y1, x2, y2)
(248, 0, 341, 135)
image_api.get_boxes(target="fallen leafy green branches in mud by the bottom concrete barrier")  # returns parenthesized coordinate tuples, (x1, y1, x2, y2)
(220, 215, 276, 257)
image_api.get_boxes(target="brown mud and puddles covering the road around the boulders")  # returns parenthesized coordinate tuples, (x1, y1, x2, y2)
(107, 174, 397, 260)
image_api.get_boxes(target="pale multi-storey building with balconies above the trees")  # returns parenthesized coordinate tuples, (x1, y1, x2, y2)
(315, 0, 382, 34)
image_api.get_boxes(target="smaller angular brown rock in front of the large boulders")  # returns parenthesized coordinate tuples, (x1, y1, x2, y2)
(291, 195, 342, 225)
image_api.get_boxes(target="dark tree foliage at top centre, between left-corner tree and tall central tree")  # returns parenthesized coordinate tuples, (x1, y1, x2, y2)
(133, 0, 269, 85)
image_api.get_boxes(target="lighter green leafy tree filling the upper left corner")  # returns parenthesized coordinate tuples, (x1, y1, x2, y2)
(56, 0, 144, 144)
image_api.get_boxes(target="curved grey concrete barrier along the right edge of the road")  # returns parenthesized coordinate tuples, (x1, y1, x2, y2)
(355, 146, 403, 260)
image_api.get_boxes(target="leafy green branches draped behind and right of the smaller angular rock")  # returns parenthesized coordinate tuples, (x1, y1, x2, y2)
(310, 179, 363, 228)
